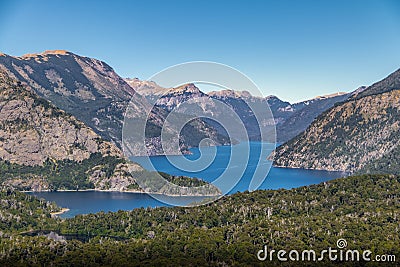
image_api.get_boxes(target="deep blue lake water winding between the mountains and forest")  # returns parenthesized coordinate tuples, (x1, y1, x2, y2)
(31, 142, 345, 217)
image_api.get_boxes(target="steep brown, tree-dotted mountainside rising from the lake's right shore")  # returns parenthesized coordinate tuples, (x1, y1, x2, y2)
(274, 70, 400, 173)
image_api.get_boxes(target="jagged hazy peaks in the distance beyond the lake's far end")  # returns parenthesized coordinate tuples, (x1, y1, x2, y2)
(131, 79, 351, 142)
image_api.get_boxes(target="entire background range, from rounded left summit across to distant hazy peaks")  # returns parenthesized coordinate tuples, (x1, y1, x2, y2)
(0, 50, 351, 155)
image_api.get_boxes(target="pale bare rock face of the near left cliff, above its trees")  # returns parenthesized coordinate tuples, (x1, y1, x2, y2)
(0, 69, 121, 166)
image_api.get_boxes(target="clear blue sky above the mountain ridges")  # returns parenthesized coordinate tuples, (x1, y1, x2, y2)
(0, 0, 400, 102)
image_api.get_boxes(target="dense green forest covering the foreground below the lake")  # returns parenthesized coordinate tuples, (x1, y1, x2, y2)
(0, 175, 400, 266)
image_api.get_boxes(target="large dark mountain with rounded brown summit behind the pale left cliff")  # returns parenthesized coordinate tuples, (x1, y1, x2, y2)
(0, 50, 226, 155)
